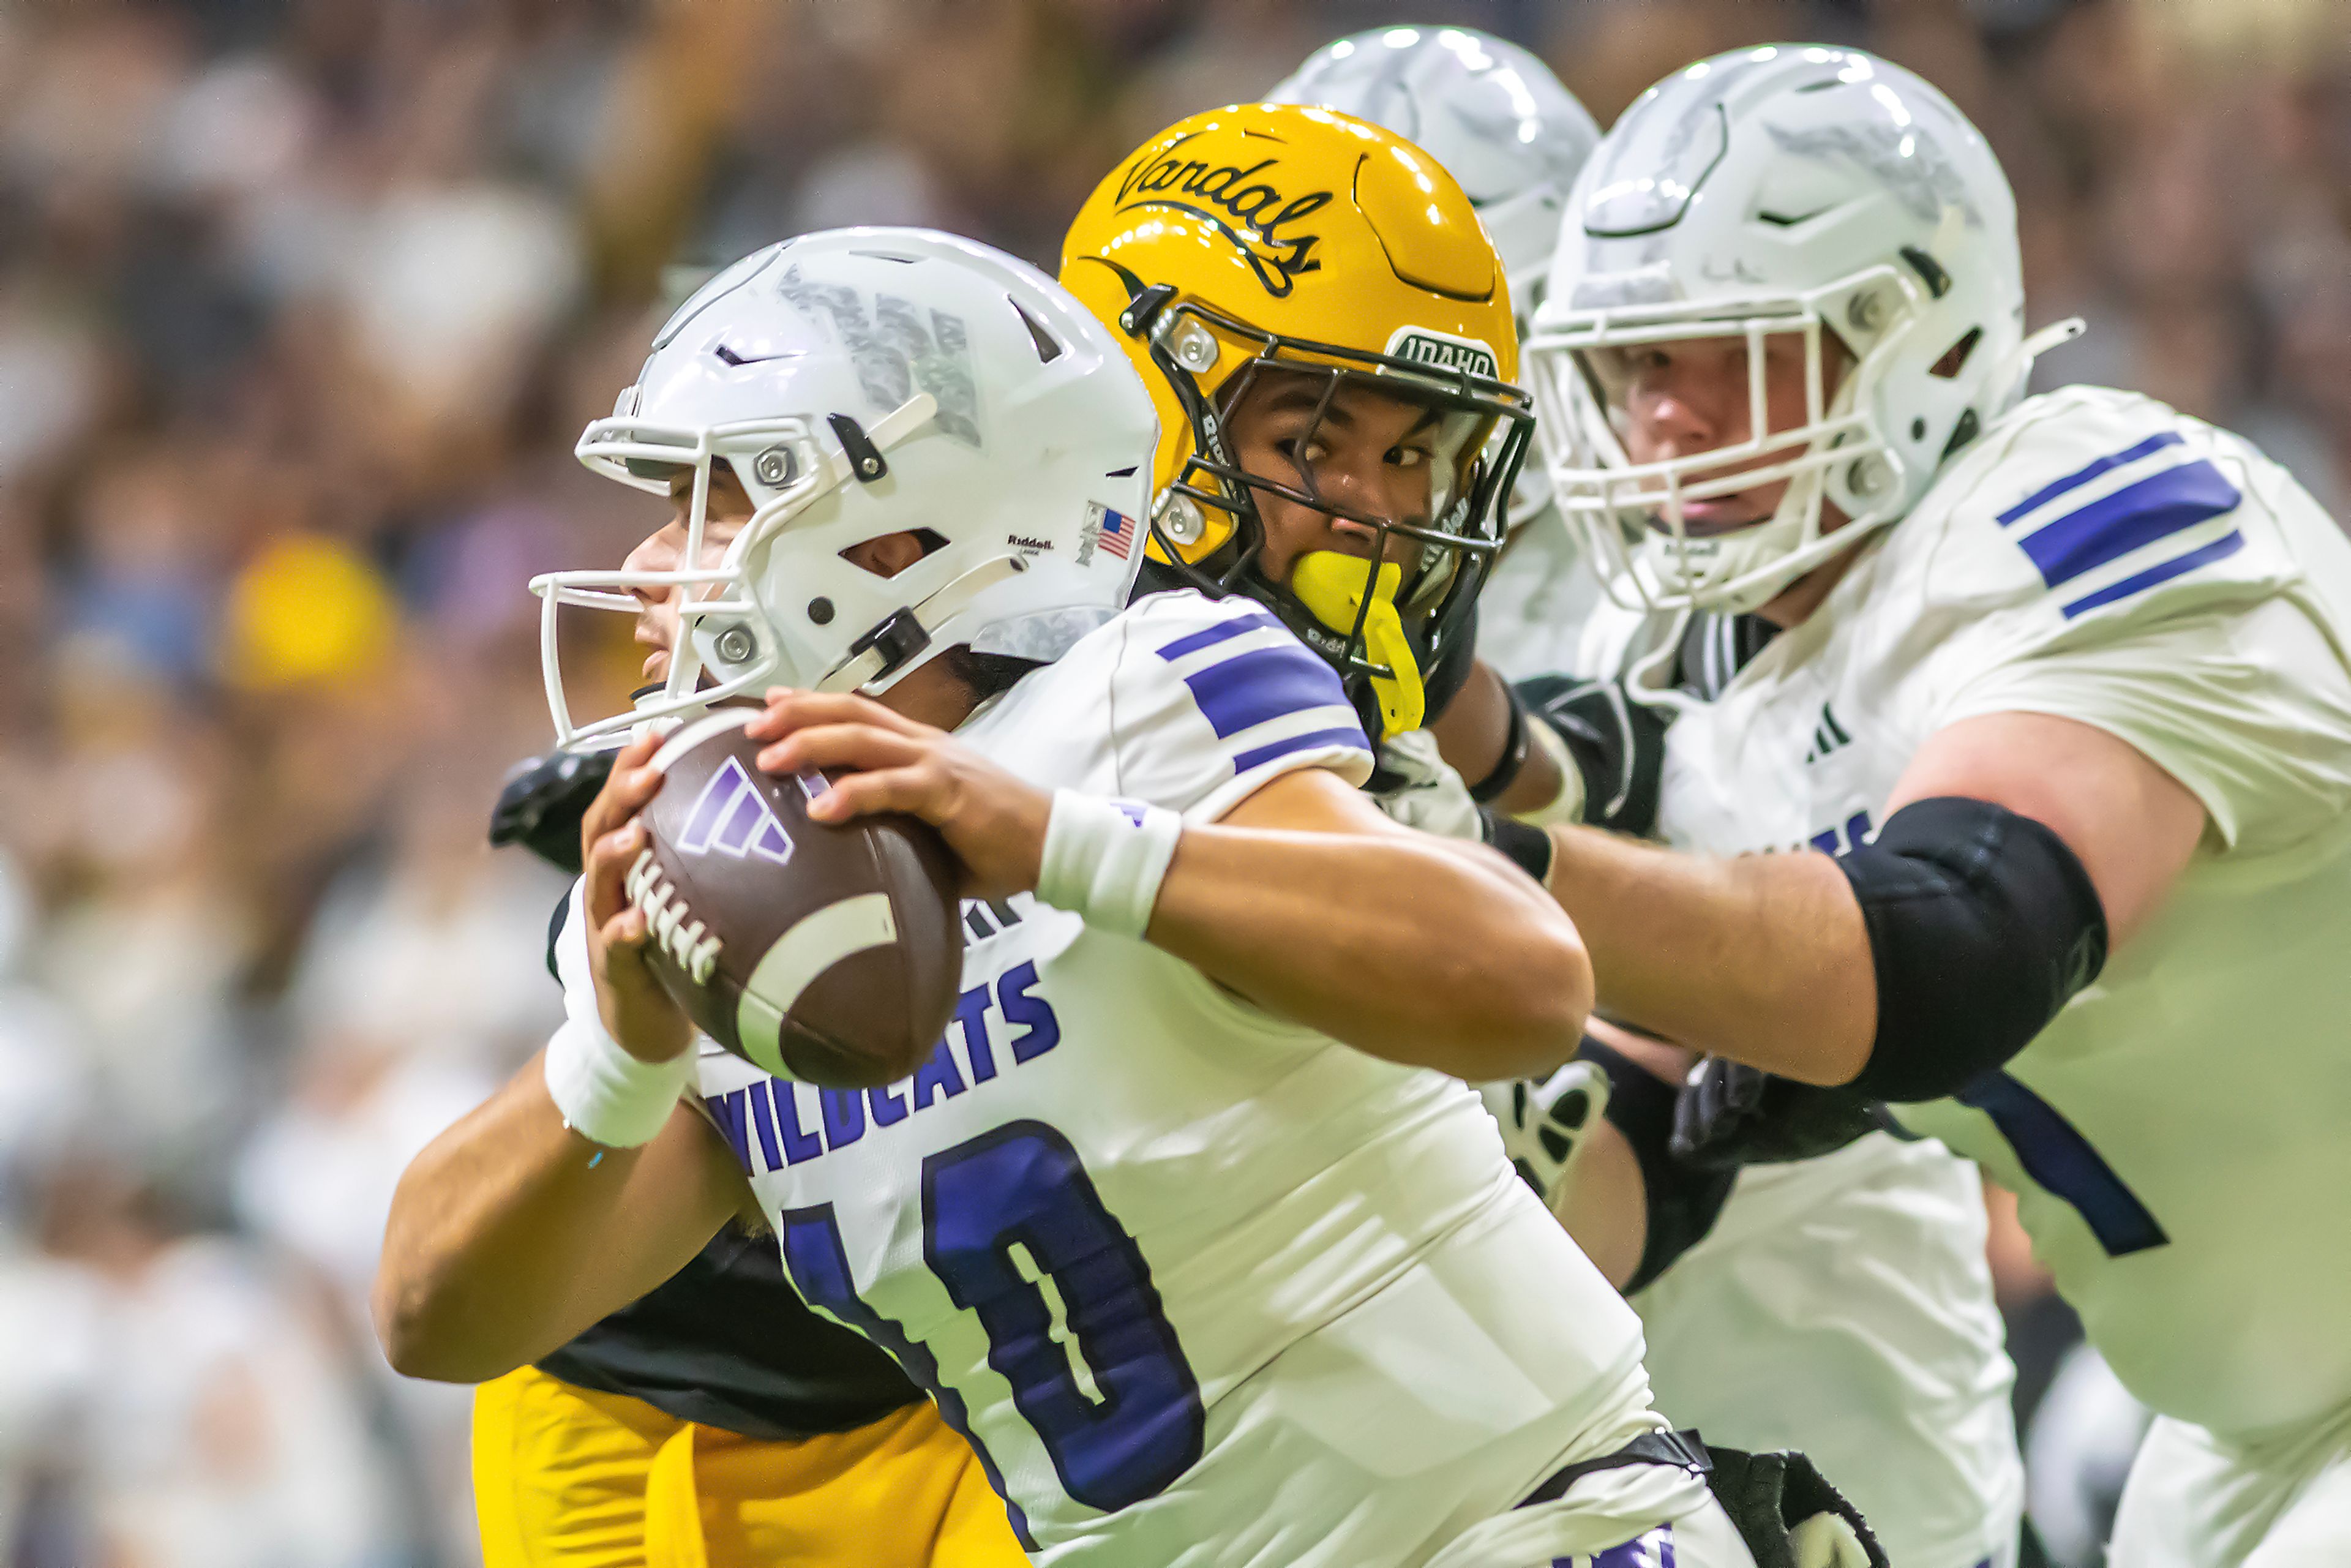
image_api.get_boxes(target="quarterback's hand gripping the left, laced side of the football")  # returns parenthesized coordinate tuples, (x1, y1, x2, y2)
(580, 736, 694, 1062)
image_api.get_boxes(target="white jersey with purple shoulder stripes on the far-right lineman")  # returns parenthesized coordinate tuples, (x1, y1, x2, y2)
(1608, 388, 2351, 1431)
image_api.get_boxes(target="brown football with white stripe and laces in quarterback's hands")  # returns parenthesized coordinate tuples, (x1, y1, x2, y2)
(628, 708, 964, 1089)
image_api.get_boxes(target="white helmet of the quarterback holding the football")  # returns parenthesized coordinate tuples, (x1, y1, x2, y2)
(531, 228, 1159, 748)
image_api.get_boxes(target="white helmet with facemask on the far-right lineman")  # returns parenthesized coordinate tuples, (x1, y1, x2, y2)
(1528, 45, 2080, 609)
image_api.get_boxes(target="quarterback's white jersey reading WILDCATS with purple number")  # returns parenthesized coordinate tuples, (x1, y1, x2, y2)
(569, 590, 1721, 1568)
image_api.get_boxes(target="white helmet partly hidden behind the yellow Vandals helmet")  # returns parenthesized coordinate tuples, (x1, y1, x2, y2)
(1265, 28, 1601, 529)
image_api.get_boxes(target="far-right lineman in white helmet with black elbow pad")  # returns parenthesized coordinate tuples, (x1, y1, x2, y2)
(1457, 45, 2351, 1568)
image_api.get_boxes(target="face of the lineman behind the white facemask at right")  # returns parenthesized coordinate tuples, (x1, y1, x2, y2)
(1584, 331, 1850, 536)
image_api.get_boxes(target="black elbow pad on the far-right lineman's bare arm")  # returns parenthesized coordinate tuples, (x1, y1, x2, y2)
(1836, 797, 2107, 1103)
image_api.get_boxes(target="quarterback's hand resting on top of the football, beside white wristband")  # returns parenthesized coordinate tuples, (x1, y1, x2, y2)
(743, 686, 1053, 898)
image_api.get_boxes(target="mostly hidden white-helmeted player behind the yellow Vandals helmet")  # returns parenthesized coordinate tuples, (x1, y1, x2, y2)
(1267, 26, 2022, 1568)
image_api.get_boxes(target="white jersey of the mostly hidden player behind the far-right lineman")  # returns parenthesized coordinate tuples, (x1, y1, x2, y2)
(1523, 625, 2024, 1568)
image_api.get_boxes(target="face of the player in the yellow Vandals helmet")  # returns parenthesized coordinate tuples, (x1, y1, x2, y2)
(1225, 372, 1439, 583)
